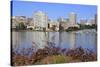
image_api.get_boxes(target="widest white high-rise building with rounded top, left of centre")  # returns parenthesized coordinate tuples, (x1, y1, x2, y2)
(33, 11, 48, 30)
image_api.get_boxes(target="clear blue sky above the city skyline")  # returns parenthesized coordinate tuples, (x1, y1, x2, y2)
(11, 0, 97, 22)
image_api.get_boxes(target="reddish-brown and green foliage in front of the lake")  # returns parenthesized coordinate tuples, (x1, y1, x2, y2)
(12, 46, 97, 66)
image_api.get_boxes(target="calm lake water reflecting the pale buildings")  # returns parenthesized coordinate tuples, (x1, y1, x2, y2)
(12, 31, 97, 51)
